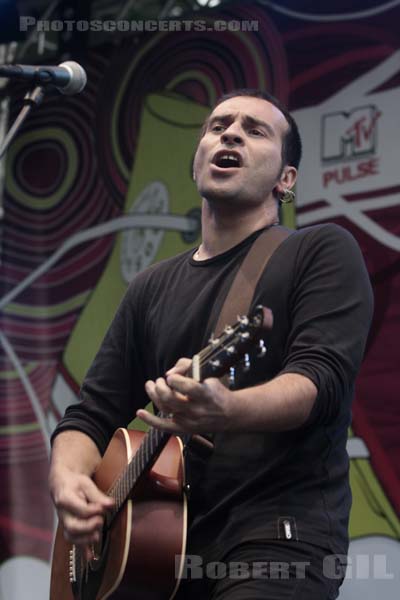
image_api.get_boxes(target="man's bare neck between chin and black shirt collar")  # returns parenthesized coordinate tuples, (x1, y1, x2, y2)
(195, 199, 279, 260)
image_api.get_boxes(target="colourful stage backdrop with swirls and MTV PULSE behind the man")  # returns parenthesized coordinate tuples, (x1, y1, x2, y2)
(0, 0, 400, 600)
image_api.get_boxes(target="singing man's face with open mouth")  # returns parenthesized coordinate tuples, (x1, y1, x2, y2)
(193, 96, 289, 206)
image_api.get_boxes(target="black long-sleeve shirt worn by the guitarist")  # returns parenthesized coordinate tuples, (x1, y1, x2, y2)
(54, 224, 372, 556)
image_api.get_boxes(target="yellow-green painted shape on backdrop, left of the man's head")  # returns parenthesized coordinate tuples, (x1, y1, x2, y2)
(64, 94, 209, 384)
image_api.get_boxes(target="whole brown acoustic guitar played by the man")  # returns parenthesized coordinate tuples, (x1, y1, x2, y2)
(50, 306, 272, 600)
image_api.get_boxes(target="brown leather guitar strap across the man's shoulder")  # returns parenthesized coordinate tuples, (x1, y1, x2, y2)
(187, 225, 294, 456)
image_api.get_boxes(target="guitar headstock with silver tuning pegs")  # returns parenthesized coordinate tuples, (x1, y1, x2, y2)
(192, 305, 273, 383)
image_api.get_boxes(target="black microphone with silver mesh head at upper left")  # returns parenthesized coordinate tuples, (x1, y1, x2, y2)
(0, 60, 87, 96)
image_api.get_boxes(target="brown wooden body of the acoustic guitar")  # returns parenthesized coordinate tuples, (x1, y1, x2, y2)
(50, 429, 187, 600)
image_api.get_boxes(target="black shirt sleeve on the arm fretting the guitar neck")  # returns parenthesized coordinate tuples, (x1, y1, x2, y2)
(280, 224, 373, 426)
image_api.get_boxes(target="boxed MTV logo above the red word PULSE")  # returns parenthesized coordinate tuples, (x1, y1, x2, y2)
(321, 105, 381, 162)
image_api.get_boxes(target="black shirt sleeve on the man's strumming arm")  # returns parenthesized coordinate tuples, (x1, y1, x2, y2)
(52, 281, 148, 454)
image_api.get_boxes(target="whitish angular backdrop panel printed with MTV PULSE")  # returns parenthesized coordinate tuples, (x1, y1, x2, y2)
(293, 50, 400, 251)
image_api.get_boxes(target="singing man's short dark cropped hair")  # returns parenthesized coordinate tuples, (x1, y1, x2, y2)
(208, 88, 302, 169)
